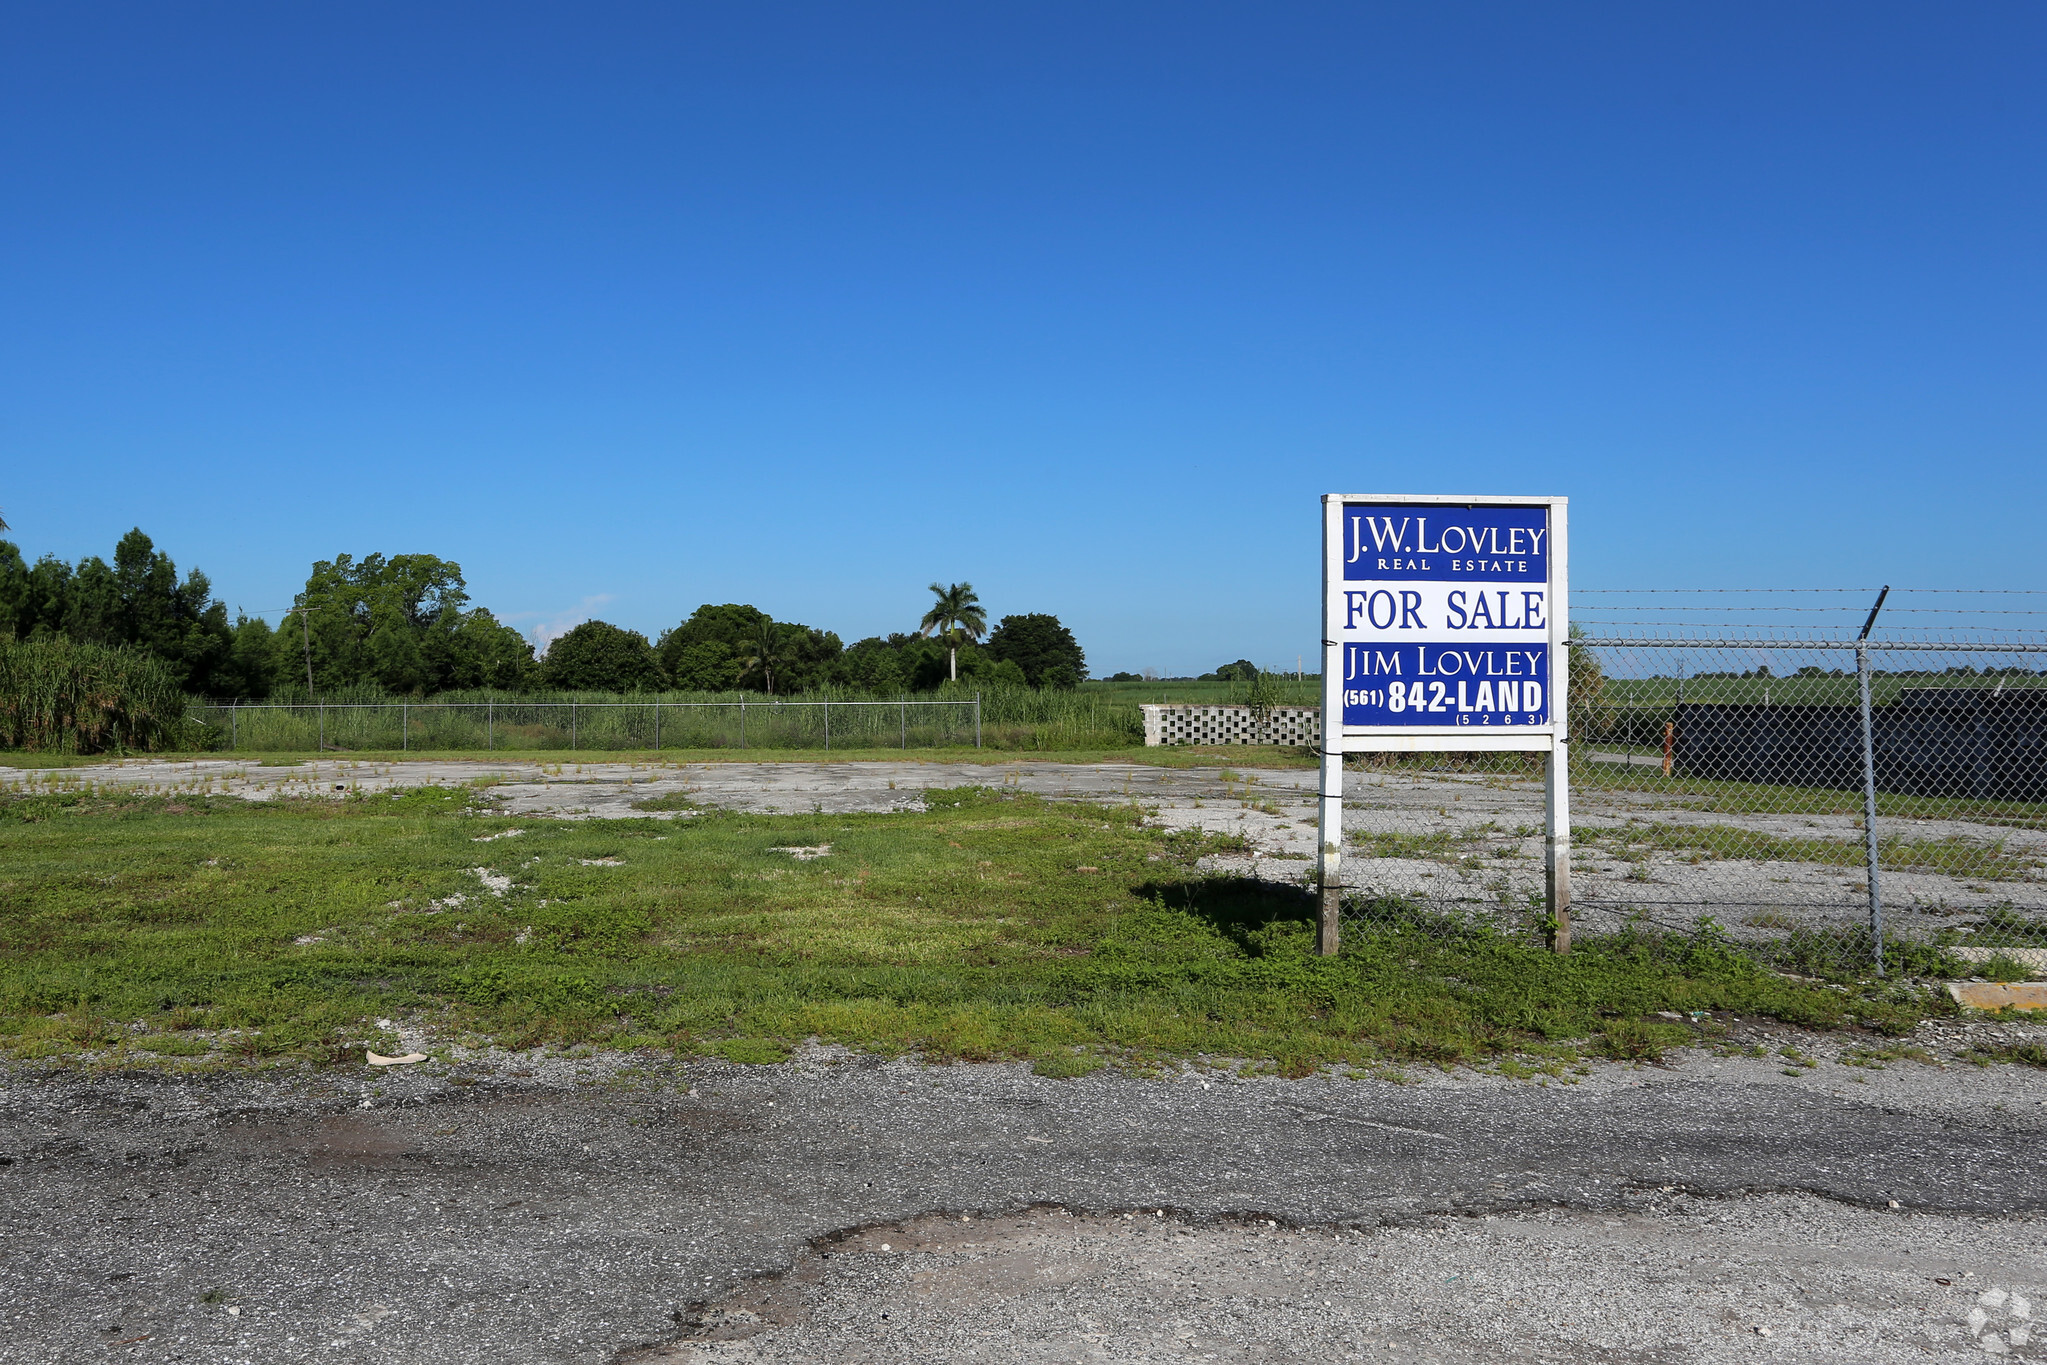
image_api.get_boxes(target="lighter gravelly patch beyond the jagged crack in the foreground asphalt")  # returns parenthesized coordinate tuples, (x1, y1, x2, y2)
(614, 1193, 2047, 1365)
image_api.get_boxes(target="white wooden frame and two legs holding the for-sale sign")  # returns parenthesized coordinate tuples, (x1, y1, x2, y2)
(1316, 493, 1570, 954)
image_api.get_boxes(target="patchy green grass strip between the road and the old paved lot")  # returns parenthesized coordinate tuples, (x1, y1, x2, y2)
(0, 788, 1951, 1074)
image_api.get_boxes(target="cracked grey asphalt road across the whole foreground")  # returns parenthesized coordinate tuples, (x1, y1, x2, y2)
(0, 1031, 2047, 1365)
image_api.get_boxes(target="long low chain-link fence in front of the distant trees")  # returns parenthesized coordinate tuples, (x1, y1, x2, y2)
(190, 696, 981, 753)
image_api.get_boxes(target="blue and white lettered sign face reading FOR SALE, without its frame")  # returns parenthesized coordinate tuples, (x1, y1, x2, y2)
(1333, 503, 1554, 729)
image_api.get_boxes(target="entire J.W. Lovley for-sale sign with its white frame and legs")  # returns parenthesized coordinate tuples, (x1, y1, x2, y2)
(1316, 493, 1570, 954)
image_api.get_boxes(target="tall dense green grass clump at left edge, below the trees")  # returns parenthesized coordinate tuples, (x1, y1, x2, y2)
(0, 639, 190, 753)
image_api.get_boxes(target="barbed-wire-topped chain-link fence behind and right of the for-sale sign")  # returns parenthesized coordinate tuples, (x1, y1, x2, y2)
(1345, 600, 2047, 978)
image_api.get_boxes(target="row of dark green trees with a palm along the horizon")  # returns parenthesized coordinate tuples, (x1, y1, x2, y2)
(0, 528, 1087, 698)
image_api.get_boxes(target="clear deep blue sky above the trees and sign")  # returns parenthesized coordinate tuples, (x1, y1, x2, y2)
(0, 2, 2047, 673)
